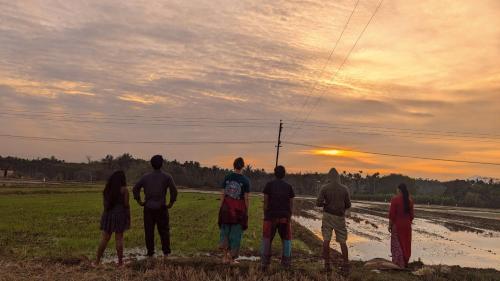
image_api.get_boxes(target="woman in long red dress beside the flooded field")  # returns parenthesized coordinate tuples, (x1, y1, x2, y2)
(389, 183, 414, 268)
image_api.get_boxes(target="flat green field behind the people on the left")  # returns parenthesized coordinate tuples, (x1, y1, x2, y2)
(0, 188, 307, 258)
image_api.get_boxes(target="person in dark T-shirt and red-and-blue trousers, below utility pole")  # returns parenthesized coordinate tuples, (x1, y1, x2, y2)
(262, 166, 295, 270)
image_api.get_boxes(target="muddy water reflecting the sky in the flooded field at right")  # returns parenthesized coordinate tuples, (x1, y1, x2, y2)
(295, 203, 500, 270)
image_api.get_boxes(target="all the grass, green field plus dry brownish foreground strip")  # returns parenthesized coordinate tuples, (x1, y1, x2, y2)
(0, 186, 500, 281)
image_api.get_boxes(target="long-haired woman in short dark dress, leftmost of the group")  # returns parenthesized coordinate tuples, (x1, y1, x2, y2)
(95, 171, 130, 266)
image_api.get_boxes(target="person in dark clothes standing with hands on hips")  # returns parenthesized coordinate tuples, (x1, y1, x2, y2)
(133, 155, 177, 257)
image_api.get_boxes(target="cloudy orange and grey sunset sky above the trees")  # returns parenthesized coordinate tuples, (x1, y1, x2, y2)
(0, 0, 500, 179)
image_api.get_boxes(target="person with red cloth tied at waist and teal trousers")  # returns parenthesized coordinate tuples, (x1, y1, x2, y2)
(218, 157, 250, 264)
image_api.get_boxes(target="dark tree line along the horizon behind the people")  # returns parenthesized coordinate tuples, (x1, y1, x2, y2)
(0, 153, 500, 208)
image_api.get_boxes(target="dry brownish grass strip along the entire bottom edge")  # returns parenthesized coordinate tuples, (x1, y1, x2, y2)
(0, 257, 500, 281)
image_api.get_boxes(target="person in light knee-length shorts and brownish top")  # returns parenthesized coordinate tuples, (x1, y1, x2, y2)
(316, 168, 351, 271)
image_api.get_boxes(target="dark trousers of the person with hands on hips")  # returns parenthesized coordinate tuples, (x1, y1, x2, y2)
(144, 207, 170, 256)
